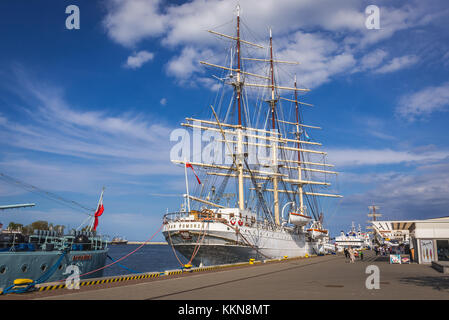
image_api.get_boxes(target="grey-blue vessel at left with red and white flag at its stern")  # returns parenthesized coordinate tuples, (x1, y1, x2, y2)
(0, 174, 108, 293)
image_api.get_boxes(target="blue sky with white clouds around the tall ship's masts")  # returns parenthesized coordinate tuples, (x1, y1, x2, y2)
(0, 0, 449, 240)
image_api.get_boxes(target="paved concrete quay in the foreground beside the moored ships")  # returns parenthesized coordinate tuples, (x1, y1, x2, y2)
(0, 251, 449, 300)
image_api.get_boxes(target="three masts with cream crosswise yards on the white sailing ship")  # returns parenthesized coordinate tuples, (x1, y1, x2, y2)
(184, 6, 341, 225)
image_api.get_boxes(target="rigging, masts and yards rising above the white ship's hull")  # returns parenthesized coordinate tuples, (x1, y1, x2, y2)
(165, 7, 341, 266)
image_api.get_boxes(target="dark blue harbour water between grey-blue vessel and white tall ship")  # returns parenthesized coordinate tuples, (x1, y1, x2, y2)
(103, 244, 186, 277)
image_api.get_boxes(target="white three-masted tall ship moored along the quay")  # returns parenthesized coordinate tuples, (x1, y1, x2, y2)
(163, 7, 341, 265)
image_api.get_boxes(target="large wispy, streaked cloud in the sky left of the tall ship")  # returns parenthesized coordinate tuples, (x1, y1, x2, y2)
(0, 69, 186, 196)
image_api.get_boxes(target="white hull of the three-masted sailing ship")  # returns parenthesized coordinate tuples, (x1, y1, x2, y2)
(163, 222, 325, 265)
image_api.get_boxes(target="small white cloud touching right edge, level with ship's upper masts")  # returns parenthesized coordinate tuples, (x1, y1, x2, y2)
(396, 82, 449, 121)
